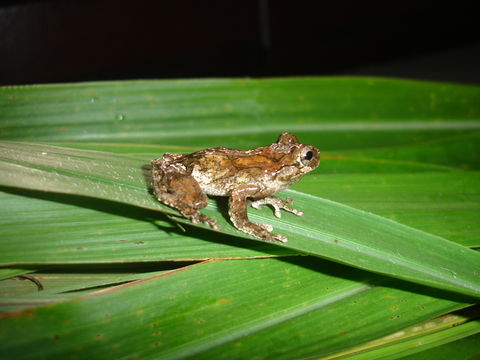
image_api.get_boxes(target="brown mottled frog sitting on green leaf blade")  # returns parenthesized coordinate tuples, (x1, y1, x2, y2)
(151, 132, 320, 243)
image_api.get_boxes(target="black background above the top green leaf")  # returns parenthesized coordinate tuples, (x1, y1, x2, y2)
(0, 0, 480, 85)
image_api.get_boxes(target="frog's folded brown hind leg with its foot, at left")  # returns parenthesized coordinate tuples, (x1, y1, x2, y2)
(152, 159, 220, 230)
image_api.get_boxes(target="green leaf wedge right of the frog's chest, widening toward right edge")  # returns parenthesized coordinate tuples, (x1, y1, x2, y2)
(294, 171, 480, 246)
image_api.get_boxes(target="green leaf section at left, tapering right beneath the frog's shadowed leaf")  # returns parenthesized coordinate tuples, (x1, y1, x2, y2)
(0, 188, 297, 264)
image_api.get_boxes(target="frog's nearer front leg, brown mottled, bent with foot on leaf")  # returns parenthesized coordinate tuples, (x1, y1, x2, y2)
(228, 185, 288, 243)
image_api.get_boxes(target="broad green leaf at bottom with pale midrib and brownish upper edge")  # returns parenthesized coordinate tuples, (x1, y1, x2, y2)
(0, 257, 472, 359)
